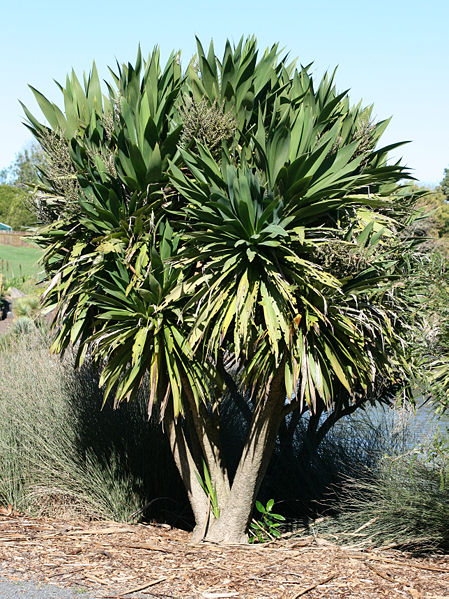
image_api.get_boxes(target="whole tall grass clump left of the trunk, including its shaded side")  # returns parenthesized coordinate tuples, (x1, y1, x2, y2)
(0, 327, 182, 521)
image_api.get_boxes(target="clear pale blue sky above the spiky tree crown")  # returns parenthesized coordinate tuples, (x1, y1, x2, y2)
(0, 0, 449, 184)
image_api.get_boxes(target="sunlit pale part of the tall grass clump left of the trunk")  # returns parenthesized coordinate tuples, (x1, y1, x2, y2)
(0, 331, 139, 520)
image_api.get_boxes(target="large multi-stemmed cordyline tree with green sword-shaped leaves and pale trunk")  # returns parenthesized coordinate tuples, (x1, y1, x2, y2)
(24, 39, 411, 543)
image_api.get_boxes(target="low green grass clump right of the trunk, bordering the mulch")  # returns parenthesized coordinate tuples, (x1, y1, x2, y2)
(300, 454, 449, 552)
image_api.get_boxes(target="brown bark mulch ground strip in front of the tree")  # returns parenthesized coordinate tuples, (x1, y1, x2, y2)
(0, 513, 449, 599)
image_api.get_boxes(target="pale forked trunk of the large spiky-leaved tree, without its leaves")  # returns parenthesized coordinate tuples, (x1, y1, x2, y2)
(165, 364, 285, 544)
